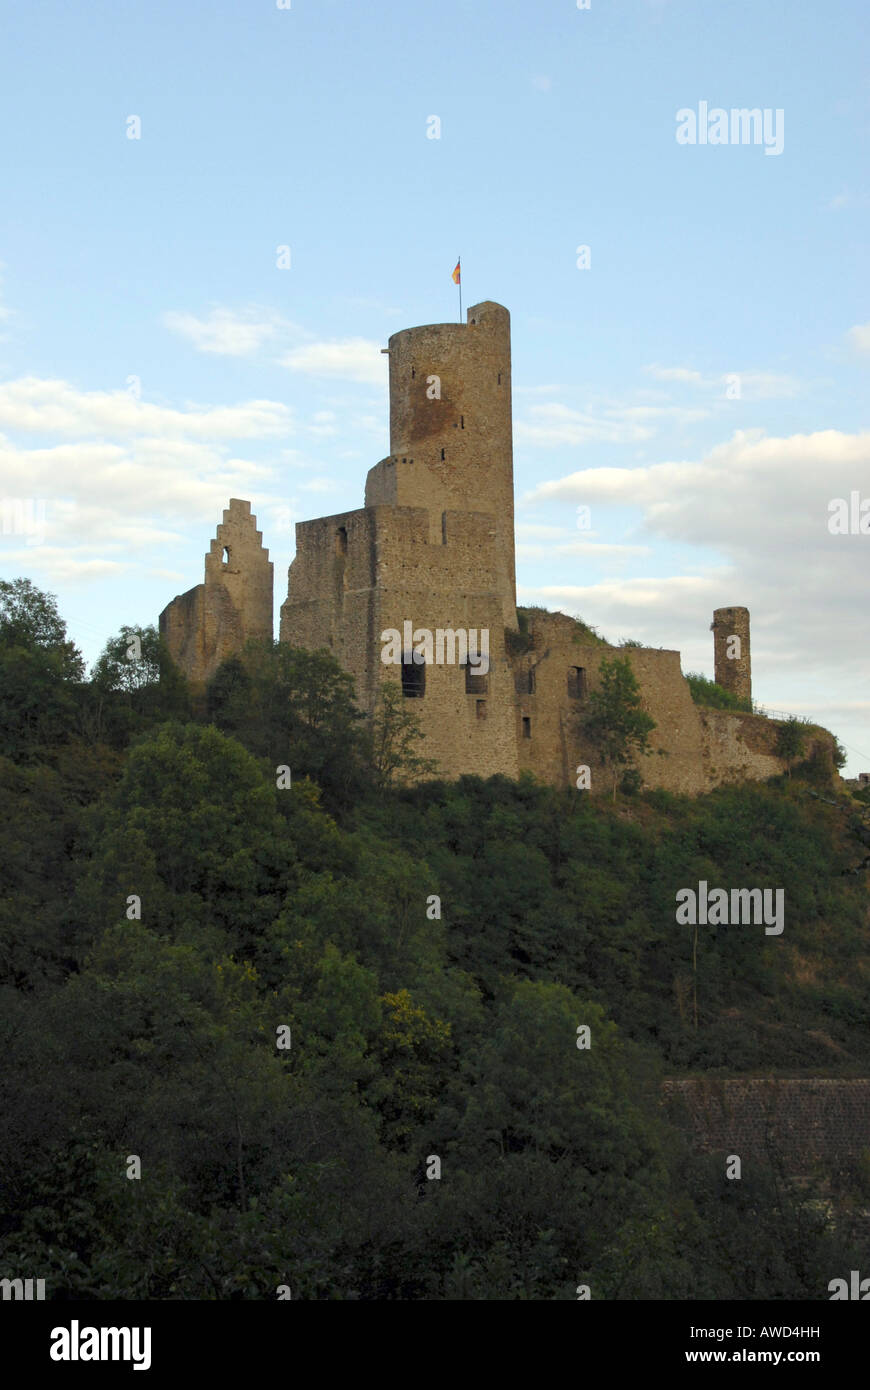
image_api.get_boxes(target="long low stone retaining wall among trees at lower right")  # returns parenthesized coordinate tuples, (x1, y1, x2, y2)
(663, 1077, 870, 1176)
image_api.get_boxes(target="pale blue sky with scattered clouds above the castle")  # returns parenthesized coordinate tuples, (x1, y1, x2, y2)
(0, 0, 870, 776)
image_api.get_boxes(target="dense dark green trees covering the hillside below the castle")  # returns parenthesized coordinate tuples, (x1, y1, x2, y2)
(0, 580, 870, 1300)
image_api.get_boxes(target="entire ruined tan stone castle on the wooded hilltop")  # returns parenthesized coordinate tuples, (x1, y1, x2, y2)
(160, 302, 834, 794)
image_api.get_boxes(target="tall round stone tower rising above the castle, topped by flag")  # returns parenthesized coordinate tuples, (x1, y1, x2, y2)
(366, 300, 517, 609)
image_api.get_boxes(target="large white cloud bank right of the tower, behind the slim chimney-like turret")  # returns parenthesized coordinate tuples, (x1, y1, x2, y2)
(514, 430, 870, 748)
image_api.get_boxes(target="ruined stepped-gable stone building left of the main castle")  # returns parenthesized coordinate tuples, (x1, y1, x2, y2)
(160, 498, 272, 689)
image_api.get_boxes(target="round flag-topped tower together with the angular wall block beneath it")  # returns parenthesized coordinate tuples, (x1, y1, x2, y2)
(281, 302, 518, 777)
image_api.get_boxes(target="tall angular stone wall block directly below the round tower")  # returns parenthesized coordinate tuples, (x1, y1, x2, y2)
(281, 506, 517, 777)
